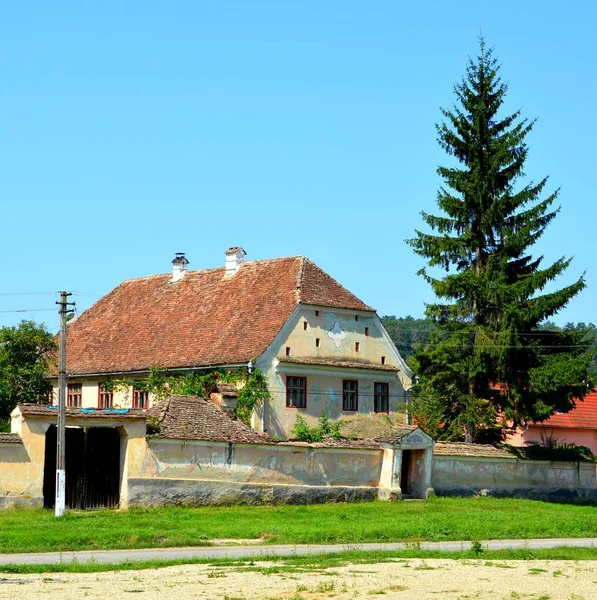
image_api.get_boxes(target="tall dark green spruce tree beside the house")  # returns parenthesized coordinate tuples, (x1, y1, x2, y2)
(408, 38, 593, 442)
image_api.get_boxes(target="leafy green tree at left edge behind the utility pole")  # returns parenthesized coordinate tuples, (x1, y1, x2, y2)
(0, 321, 56, 428)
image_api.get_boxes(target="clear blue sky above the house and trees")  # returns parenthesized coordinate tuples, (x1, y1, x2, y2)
(0, 0, 597, 330)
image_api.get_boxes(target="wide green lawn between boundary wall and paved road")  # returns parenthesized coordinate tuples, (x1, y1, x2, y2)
(0, 498, 597, 553)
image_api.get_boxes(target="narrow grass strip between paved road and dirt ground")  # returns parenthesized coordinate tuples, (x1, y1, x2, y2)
(0, 546, 597, 576)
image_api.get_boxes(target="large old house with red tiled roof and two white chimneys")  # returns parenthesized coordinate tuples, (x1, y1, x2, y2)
(53, 247, 412, 438)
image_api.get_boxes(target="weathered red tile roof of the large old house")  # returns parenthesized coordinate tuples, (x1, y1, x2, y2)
(62, 256, 373, 375)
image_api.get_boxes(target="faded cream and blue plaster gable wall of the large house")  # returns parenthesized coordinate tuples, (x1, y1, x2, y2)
(252, 306, 410, 438)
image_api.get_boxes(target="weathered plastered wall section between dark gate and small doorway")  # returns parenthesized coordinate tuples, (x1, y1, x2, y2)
(128, 438, 383, 506)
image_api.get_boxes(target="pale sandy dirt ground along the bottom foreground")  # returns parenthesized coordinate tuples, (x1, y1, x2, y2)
(0, 559, 597, 600)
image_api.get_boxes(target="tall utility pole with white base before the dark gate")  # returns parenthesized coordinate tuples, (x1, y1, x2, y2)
(54, 292, 75, 517)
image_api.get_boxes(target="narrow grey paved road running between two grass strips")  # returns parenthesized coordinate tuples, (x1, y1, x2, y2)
(0, 538, 597, 565)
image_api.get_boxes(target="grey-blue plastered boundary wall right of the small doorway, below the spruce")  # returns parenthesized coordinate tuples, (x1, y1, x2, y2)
(431, 454, 597, 502)
